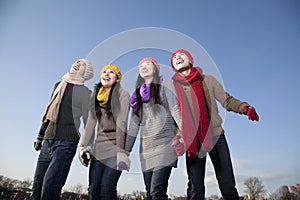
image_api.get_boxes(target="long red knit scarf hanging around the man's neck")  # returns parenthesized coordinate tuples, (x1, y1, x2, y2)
(172, 67, 213, 157)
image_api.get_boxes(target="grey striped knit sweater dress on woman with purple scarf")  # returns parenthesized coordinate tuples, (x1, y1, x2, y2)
(125, 80, 181, 171)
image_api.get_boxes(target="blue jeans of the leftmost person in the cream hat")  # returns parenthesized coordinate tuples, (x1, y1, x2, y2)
(32, 139, 77, 200)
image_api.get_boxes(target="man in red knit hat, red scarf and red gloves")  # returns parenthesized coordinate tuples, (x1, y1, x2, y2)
(171, 49, 259, 200)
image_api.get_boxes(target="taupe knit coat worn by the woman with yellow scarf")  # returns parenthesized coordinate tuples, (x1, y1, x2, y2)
(80, 89, 129, 160)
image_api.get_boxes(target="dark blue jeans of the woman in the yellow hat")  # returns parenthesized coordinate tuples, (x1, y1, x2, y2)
(89, 157, 122, 200)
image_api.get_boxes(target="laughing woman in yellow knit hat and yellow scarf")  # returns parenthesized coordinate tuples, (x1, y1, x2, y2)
(80, 64, 130, 200)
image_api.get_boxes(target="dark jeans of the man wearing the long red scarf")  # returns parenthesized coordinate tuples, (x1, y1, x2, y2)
(186, 134, 239, 200)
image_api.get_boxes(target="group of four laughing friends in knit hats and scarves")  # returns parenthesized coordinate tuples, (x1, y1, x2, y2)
(32, 49, 259, 200)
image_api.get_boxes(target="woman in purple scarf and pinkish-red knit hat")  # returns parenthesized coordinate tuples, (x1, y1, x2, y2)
(125, 58, 181, 200)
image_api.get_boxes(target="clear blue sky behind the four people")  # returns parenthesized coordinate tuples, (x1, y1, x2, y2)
(0, 0, 300, 196)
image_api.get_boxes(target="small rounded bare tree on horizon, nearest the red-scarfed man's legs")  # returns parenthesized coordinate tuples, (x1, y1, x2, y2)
(244, 177, 265, 200)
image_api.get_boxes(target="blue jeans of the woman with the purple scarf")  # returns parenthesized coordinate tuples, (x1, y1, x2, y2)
(143, 166, 172, 200)
